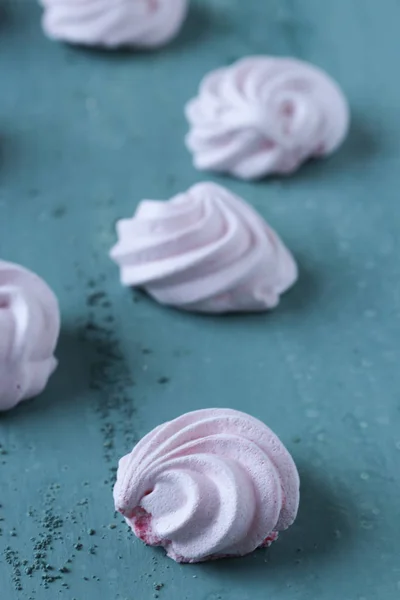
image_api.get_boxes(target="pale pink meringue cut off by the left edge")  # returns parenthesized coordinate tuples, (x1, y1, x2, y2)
(0, 261, 60, 410)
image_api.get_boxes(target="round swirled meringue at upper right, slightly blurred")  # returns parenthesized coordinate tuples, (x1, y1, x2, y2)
(186, 56, 349, 179)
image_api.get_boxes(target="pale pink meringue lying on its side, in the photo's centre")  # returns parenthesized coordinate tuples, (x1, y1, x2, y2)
(110, 183, 297, 313)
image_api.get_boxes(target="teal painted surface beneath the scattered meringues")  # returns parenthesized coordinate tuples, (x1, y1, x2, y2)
(0, 0, 400, 600)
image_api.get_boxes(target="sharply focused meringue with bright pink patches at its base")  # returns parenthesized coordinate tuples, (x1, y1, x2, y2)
(114, 409, 299, 563)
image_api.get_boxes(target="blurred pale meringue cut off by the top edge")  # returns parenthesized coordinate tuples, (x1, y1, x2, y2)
(41, 0, 188, 48)
